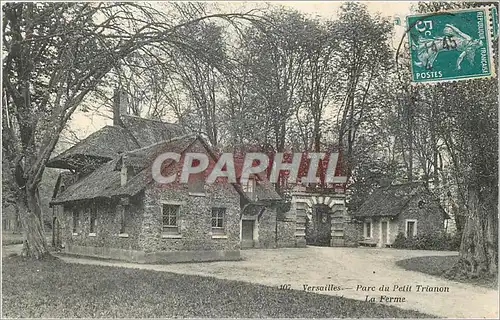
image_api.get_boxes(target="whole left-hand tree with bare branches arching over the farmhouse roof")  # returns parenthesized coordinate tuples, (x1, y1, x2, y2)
(2, 2, 262, 258)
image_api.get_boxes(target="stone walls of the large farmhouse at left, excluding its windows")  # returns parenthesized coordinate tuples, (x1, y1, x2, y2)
(58, 184, 240, 263)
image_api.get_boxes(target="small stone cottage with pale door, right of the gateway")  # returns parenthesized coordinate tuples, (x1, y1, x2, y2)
(354, 182, 449, 247)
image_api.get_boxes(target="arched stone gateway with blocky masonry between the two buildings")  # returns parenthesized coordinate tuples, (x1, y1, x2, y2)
(292, 192, 348, 247)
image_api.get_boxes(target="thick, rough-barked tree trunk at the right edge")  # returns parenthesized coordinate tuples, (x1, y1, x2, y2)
(460, 187, 498, 277)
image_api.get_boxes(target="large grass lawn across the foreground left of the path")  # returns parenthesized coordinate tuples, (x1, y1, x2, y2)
(2, 257, 432, 318)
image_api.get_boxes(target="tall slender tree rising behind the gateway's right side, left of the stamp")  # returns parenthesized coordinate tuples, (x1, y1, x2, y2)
(334, 2, 392, 177)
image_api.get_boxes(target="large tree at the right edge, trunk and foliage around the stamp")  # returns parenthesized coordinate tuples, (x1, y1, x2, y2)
(412, 2, 498, 276)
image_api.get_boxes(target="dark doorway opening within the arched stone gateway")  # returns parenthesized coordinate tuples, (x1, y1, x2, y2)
(306, 204, 332, 247)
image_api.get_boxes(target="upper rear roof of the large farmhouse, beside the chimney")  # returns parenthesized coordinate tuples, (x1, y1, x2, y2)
(47, 115, 184, 169)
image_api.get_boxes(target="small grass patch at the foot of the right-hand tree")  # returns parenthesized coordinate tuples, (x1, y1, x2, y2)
(396, 256, 498, 289)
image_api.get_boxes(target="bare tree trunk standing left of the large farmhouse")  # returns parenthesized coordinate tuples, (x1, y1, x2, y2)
(17, 188, 49, 259)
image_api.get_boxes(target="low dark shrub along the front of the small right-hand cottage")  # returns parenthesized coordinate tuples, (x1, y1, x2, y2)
(392, 232, 461, 251)
